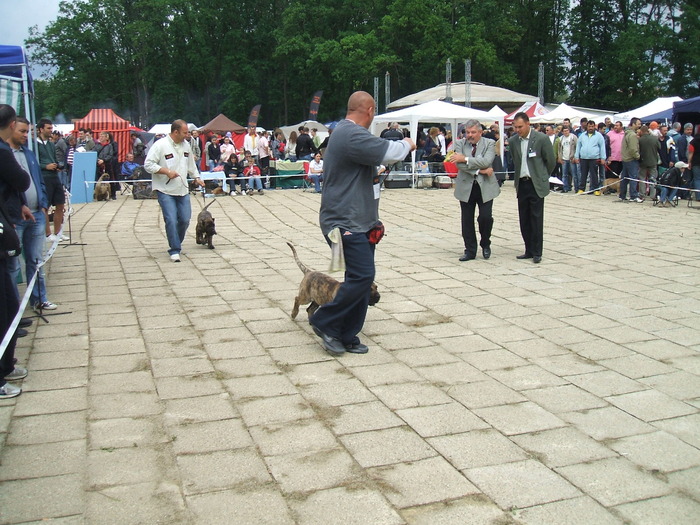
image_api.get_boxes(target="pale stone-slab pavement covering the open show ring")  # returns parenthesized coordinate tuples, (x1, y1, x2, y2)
(0, 183, 700, 525)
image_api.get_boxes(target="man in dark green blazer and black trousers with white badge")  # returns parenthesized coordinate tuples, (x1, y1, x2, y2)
(510, 112, 556, 264)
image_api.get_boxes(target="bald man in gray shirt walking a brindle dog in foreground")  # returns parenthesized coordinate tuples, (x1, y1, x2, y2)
(309, 91, 416, 355)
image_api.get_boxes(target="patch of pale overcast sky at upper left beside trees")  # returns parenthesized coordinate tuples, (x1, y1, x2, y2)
(0, 0, 60, 78)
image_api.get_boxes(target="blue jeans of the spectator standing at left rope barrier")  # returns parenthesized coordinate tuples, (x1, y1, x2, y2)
(7, 211, 48, 306)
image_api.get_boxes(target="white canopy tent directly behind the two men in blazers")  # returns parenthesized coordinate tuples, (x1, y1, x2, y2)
(372, 100, 503, 176)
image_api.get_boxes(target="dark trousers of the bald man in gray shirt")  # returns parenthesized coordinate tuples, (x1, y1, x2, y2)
(311, 229, 375, 345)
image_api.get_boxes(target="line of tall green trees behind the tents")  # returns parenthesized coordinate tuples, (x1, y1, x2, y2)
(27, 0, 700, 127)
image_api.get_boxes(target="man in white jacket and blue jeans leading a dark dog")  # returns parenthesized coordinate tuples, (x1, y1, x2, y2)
(144, 120, 204, 262)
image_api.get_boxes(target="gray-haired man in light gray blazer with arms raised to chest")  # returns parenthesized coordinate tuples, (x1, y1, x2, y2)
(452, 120, 494, 261)
